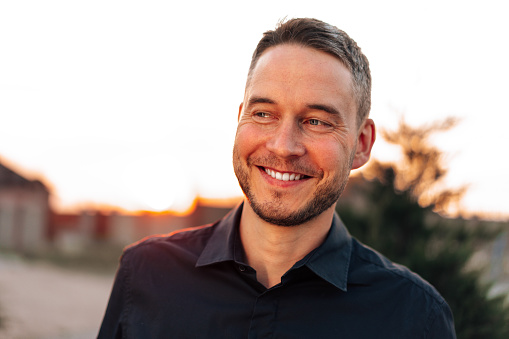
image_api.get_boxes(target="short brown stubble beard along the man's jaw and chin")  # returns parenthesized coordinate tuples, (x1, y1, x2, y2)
(233, 147, 354, 227)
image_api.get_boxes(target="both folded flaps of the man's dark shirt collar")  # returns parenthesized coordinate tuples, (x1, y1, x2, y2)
(196, 203, 352, 292)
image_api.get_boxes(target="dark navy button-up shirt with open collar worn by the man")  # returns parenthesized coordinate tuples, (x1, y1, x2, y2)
(98, 205, 455, 339)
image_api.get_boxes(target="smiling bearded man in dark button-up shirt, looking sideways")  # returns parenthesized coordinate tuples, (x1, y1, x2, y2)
(99, 19, 455, 339)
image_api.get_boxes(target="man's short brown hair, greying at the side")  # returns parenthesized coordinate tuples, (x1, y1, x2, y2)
(247, 18, 371, 126)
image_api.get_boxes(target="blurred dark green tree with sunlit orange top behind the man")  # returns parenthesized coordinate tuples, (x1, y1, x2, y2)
(337, 121, 509, 339)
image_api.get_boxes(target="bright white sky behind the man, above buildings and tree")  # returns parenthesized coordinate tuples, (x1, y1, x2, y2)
(0, 0, 509, 219)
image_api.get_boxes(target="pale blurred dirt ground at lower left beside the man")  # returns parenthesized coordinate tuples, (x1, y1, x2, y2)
(0, 254, 114, 339)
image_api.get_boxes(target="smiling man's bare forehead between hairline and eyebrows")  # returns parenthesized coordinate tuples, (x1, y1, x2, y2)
(245, 45, 356, 119)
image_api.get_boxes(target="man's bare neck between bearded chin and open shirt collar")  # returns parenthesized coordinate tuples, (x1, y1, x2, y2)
(240, 201, 334, 288)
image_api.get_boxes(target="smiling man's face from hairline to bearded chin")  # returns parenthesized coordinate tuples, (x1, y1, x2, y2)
(233, 45, 372, 226)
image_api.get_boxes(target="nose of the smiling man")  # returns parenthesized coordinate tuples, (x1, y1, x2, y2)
(266, 121, 306, 158)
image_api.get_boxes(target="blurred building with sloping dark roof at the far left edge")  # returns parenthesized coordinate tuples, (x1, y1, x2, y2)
(0, 163, 49, 253)
